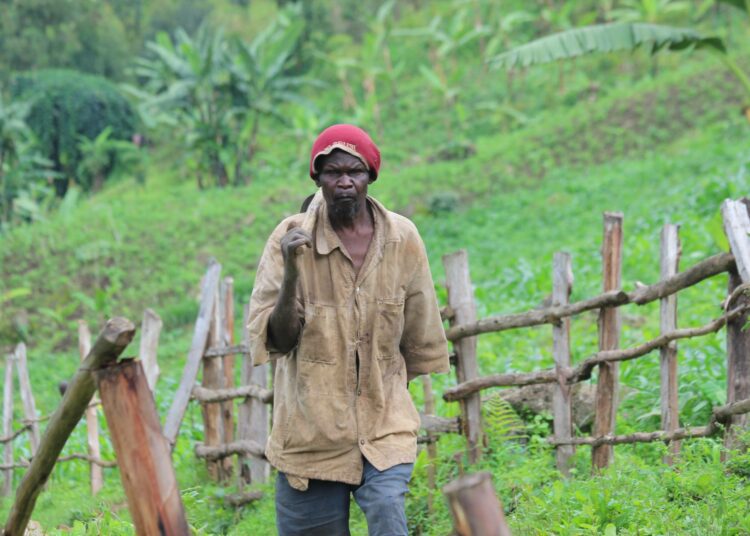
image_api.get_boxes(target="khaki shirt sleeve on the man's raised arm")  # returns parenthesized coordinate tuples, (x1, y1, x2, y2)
(247, 222, 302, 365)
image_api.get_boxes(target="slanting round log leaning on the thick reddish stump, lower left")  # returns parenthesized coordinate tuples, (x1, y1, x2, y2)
(5, 317, 135, 536)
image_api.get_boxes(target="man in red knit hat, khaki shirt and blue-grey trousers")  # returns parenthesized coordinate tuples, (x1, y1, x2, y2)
(249, 125, 449, 536)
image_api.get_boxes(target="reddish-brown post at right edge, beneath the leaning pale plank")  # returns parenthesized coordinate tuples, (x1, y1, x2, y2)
(724, 271, 750, 450)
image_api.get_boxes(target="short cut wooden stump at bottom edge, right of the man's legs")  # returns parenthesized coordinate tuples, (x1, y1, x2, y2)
(443, 473, 510, 536)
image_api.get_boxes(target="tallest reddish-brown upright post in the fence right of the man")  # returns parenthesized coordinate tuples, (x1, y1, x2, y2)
(591, 212, 623, 471)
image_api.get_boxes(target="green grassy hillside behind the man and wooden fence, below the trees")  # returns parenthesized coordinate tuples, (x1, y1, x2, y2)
(0, 23, 750, 534)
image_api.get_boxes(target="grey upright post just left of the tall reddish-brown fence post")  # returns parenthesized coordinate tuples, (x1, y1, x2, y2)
(552, 252, 575, 476)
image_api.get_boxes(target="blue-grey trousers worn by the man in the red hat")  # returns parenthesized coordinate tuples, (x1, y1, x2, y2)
(276, 460, 414, 536)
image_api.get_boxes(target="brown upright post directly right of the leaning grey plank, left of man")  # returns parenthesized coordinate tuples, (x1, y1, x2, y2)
(201, 281, 225, 481)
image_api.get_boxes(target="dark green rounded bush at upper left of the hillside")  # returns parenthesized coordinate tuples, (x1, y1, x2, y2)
(12, 70, 138, 196)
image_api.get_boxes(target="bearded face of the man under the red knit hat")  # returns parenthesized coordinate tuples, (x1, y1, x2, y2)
(315, 150, 370, 223)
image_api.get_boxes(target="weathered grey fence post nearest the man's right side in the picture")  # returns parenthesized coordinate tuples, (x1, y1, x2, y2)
(443, 249, 482, 463)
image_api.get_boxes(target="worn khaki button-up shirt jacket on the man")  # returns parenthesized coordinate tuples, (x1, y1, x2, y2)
(249, 198, 449, 484)
